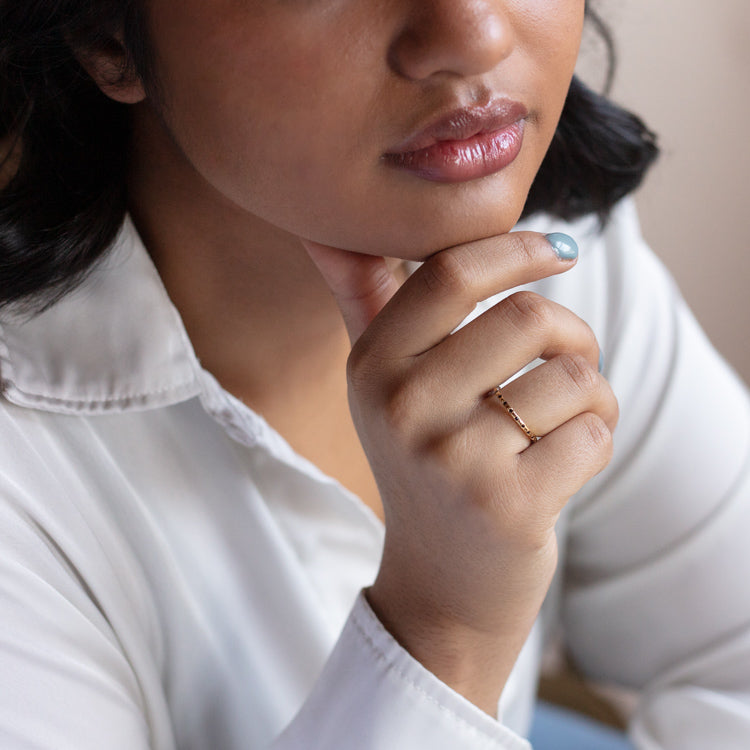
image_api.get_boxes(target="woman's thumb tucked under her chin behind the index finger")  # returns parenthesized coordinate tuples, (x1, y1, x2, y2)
(302, 240, 399, 344)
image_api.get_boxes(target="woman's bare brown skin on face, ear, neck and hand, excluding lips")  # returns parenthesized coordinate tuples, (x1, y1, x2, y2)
(82, 0, 617, 713)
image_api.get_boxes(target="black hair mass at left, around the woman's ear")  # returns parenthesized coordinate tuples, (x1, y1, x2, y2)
(0, 0, 153, 310)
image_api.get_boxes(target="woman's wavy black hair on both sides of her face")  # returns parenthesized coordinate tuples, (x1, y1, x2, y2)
(0, 0, 657, 312)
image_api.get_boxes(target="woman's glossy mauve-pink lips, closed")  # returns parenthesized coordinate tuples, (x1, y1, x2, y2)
(385, 99, 528, 182)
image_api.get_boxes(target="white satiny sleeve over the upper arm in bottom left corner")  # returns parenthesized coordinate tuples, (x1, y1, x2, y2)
(0, 488, 152, 750)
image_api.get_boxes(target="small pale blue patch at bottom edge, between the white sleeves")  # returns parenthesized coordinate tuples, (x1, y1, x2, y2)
(529, 703, 634, 750)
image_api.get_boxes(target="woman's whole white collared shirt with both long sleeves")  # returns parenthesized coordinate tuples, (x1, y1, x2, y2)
(0, 201, 750, 750)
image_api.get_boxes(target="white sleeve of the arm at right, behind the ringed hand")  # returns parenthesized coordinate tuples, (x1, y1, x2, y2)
(563, 207, 750, 750)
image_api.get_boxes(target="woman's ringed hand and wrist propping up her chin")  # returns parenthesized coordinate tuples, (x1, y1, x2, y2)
(304, 232, 617, 713)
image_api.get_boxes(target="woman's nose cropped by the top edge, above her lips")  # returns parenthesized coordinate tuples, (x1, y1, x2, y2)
(389, 0, 513, 80)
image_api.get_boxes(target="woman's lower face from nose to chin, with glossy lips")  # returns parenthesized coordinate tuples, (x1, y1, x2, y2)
(141, 0, 584, 259)
